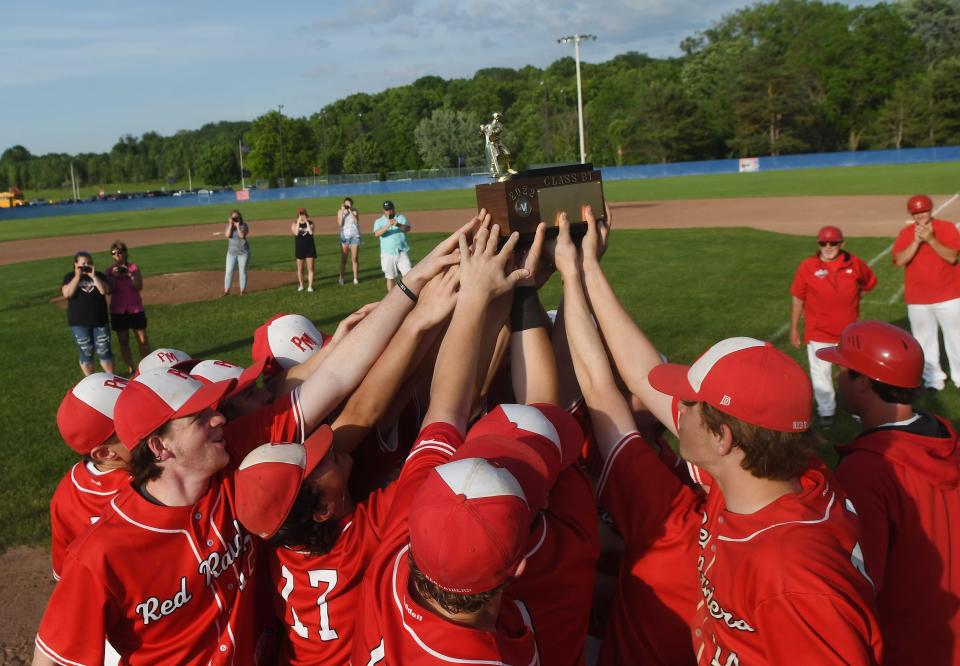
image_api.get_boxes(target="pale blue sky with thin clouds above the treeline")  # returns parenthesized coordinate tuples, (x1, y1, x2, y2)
(0, 0, 867, 154)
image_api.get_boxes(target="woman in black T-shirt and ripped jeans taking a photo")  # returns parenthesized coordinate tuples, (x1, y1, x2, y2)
(60, 252, 113, 376)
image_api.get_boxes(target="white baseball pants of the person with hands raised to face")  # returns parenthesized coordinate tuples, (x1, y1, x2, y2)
(907, 298, 960, 390)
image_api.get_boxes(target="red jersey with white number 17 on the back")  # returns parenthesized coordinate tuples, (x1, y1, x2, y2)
(269, 484, 396, 664)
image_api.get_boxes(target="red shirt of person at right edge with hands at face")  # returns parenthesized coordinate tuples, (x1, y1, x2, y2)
(893, 219, 960, 305)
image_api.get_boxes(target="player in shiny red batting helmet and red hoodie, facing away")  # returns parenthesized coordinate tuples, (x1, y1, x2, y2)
(818, 321, 960, 665)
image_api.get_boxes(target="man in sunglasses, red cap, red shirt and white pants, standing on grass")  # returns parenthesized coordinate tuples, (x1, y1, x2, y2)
(790, 227, 877, 428)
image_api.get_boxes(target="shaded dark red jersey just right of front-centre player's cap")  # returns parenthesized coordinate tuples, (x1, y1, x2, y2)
(509, 465, 600, 666)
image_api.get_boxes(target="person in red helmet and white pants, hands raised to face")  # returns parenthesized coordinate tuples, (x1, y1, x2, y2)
(893, 194, 960, 391)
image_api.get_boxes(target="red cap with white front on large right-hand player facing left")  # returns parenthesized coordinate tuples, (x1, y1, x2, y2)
(649, 338, 813, 432)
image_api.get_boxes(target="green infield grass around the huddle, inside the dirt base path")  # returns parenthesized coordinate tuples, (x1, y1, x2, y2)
(0, 224, 960, 548)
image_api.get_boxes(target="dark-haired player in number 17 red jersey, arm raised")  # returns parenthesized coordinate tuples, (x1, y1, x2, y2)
(237, 271, 457, 664)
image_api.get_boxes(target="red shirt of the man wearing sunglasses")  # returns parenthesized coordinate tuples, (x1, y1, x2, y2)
(790, 252, 877, 342)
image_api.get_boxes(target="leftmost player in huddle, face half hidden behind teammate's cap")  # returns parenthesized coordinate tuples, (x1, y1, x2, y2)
(50, 372, 130, 580)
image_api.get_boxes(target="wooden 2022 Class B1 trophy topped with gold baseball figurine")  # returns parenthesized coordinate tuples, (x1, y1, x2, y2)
(476, 113, 605, 245)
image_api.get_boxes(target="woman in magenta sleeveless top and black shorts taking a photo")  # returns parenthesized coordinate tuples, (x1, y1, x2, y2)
(107, 241, 150, 374)
